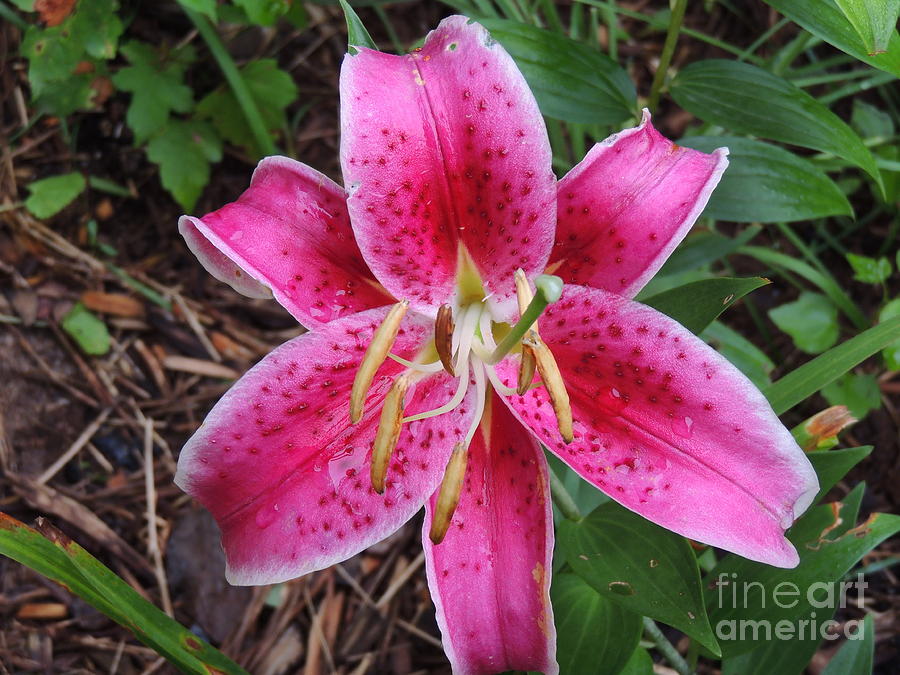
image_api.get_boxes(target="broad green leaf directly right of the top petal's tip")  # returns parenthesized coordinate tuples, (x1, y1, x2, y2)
(480, 19, 637, 124)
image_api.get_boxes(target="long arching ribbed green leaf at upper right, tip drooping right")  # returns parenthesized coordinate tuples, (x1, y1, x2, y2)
(671, 59, 884, 197)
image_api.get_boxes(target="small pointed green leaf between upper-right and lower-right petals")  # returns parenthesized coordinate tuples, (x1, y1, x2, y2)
(641, 277, 770, 334)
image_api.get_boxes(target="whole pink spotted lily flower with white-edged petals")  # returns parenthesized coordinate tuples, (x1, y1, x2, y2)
(176, 16, 818, 673)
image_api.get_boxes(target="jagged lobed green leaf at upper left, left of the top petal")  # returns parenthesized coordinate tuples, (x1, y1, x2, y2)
(112, 42, 194, 145)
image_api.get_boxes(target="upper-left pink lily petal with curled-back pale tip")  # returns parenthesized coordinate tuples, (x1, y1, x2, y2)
(178, 157, 392, 328)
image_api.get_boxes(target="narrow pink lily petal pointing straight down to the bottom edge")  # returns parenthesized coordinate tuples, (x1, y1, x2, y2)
(422, 397, 559, 675)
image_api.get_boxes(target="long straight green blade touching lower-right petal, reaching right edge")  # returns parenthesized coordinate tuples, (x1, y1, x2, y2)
(763, 316, 900, 415)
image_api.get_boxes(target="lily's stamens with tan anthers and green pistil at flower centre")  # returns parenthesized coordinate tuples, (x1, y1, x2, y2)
(350, 270, 572, 544)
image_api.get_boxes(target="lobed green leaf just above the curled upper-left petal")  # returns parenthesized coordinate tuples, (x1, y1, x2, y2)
(147, 119, 222, 211)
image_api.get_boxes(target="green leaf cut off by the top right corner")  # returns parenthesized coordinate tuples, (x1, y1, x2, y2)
(765, 0, 900, 77)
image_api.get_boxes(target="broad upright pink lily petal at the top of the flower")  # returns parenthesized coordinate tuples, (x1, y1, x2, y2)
(341, 16, 556, 319)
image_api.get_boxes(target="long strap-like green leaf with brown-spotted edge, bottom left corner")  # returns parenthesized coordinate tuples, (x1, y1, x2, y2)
(0, 513, 246, 675)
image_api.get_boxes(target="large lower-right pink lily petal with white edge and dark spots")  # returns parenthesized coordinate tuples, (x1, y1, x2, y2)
(499, 286, 818, 567)
